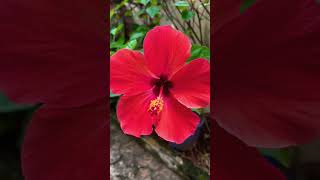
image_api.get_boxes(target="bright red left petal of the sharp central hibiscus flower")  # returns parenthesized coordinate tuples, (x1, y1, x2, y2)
(110, 49, 152, 94)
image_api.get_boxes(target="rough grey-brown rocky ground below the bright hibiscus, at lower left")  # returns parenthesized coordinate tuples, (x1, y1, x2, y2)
(110, 121, 181, 180)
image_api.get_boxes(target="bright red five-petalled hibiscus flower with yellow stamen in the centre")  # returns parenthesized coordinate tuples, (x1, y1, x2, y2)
(110, 26, 210, 144)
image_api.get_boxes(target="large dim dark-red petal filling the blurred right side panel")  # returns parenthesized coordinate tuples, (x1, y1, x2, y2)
(213, 0, 320, 147)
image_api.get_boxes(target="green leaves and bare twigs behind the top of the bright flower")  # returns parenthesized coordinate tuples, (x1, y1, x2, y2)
(110, 0, 210, 50)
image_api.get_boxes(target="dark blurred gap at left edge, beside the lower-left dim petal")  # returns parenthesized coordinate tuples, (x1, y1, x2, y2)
(0, 91, 40, 180)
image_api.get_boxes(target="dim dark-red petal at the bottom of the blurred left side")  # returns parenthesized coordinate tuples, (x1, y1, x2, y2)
(22, 101, 109, 180)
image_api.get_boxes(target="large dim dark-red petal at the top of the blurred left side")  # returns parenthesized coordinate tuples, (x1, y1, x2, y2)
(0, 0, 107, 107)
